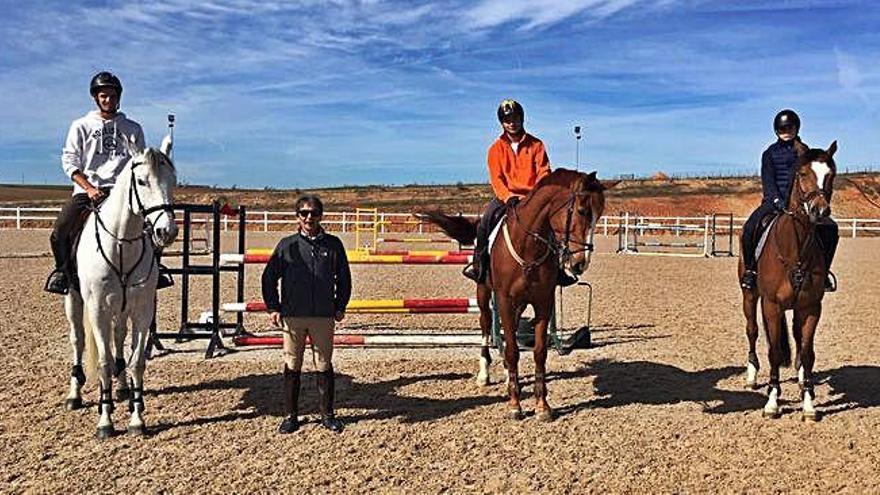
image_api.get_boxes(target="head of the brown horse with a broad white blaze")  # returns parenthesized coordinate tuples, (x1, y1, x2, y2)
(789, 141, 837, 223)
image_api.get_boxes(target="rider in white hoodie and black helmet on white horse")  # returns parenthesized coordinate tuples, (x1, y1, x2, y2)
(46, 72, 172, 294)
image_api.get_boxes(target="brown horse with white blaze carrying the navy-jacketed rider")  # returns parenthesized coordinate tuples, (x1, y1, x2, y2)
(739, 141, 837, 421)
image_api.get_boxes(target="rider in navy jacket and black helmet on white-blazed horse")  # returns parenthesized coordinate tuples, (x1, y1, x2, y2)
(740, 110, 839, 292)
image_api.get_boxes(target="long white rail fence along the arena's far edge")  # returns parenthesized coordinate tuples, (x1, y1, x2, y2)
(0, 206, 880, 237)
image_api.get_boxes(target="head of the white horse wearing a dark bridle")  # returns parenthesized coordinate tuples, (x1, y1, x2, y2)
(129, 136, 177, 247)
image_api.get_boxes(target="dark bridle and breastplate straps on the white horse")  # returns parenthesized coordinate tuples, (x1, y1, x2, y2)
(91, 155, 174, 311)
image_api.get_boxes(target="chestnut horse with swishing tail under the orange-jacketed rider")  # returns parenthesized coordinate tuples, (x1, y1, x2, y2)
(417, 169, 613, 421)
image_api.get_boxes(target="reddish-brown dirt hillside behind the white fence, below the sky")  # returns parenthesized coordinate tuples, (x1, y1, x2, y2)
(0, 173, 880, 218)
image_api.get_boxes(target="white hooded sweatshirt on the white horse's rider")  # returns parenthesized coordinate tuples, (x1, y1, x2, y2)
(61, 110, 144, 194)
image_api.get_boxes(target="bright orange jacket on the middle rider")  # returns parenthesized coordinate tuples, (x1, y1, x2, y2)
(487, 133, 550, 202)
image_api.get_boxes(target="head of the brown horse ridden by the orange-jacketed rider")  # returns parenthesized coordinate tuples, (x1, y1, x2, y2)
(550, 169, 617, 275)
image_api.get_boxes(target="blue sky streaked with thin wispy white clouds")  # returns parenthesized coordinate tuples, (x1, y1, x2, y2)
(0, 0, 880, 188)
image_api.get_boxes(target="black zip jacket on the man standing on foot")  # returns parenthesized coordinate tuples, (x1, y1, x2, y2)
(263, 232, 351, 317)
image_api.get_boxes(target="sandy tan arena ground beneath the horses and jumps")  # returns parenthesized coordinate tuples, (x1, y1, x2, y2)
(0, 231, 880, 493)
